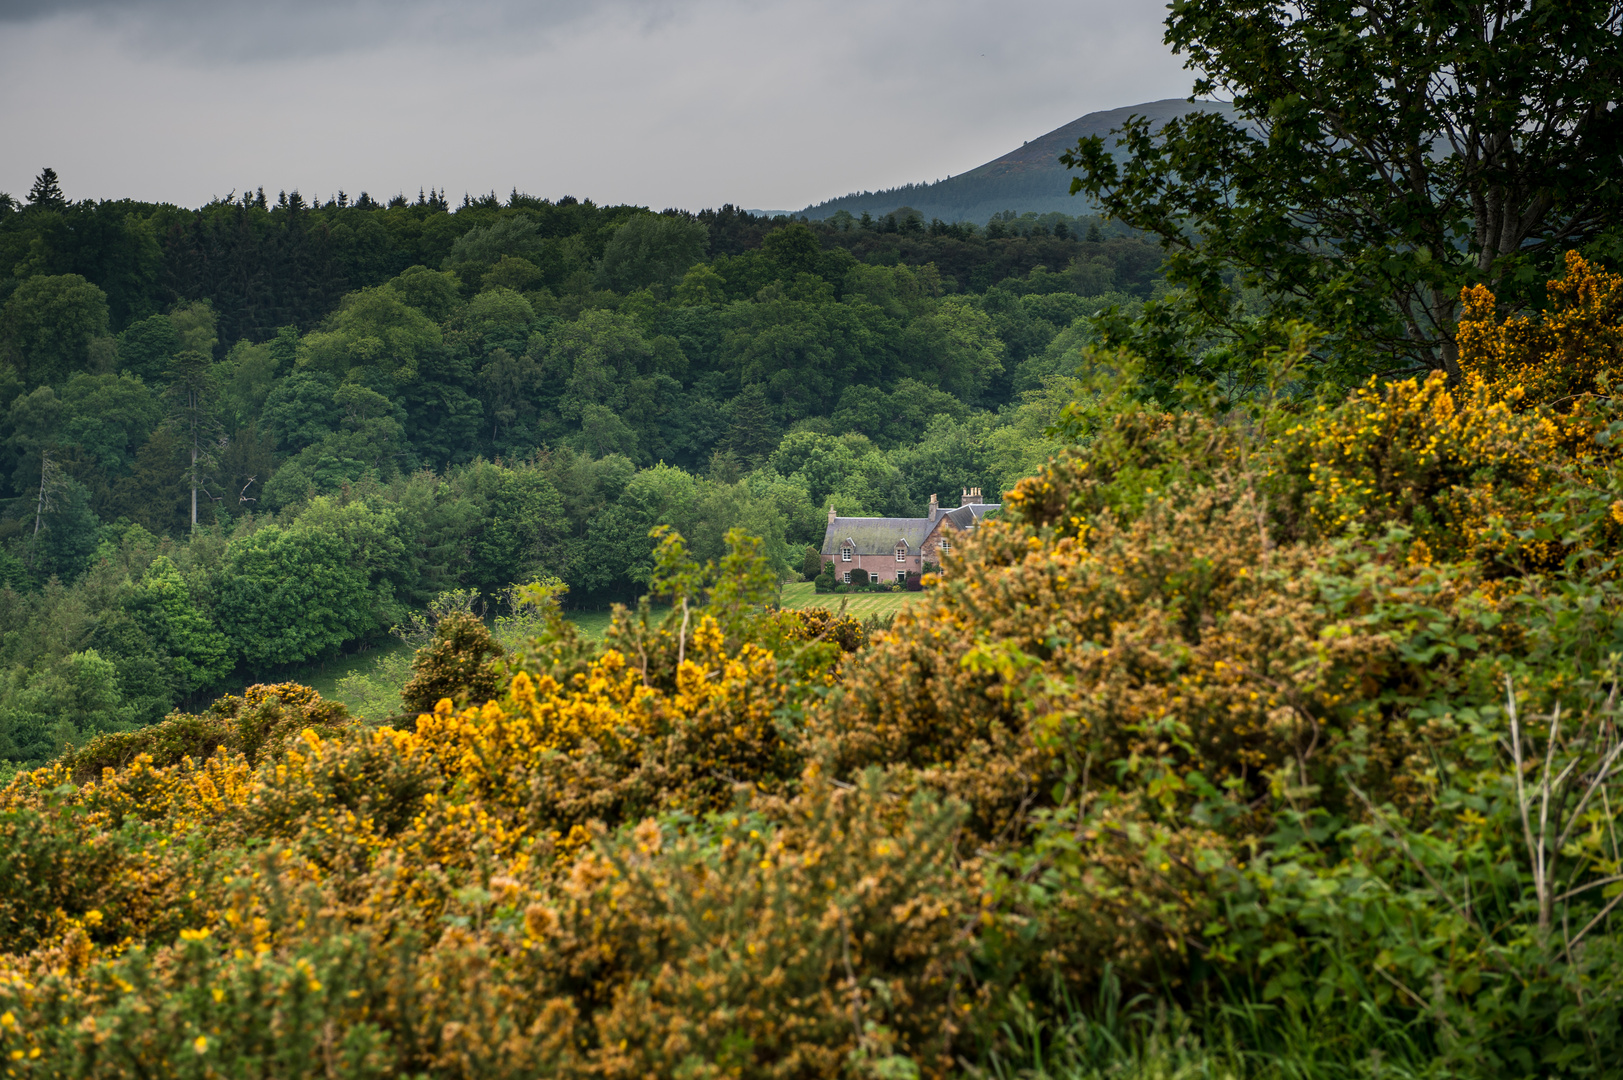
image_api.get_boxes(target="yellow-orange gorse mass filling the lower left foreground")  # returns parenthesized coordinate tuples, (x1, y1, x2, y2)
(0, 584, 966, 1077)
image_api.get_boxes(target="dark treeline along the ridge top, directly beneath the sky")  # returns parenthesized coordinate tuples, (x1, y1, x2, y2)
(0, 169, 1159, 349)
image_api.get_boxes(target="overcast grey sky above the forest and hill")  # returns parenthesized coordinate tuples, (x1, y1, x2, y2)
(0, 0, 1191, 210)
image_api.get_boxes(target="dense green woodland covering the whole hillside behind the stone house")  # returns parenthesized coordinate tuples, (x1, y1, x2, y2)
(0, 171, 1160, 762)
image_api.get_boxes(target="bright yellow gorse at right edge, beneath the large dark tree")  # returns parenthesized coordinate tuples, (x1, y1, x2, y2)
(1268, 252, 1623, 577)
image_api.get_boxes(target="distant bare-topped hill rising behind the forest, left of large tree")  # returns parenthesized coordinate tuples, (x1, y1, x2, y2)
(795, 97, 1232, 224)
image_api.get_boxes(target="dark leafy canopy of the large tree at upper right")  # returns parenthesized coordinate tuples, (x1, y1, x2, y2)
(1066, 0, 1623, 378)
